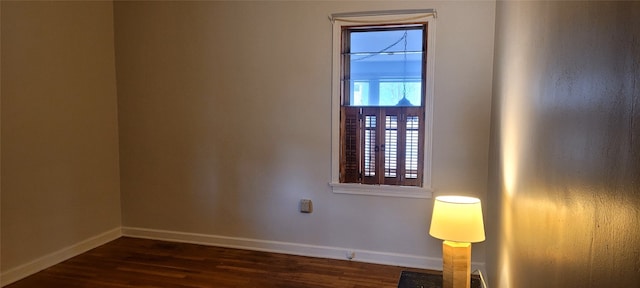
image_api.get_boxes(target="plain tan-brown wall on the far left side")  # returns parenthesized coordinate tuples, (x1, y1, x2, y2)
(0, 1, 121, 272)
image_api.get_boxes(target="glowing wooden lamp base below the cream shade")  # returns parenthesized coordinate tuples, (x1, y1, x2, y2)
(442, 241, 471, 288)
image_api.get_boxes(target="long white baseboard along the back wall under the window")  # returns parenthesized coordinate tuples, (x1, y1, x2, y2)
(122, 227, 460, 270)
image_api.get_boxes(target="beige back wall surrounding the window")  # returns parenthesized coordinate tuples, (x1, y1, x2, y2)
(114, 1, 495, 268)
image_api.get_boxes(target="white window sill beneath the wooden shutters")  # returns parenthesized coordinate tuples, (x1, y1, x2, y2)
(329, 182, 433, 199)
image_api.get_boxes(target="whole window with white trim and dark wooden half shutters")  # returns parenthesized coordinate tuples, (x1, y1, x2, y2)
(331, 11, 434, 197)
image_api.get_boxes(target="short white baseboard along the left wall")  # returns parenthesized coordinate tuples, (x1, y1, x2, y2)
(0, 227, 122, 287)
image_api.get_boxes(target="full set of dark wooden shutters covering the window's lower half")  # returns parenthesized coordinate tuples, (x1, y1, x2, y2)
(340, 106, 425, 186)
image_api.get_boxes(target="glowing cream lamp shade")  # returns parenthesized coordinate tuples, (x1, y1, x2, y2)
(429, 196, 485, 243)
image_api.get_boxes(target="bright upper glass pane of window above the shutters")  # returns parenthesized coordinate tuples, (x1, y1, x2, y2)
(344, 27, 424, 106)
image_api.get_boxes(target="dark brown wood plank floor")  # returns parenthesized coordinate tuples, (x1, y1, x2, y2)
(7, 237, 437, 288)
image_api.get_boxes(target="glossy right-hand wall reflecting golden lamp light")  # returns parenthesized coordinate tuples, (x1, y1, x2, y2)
(487, 1, 640, 288)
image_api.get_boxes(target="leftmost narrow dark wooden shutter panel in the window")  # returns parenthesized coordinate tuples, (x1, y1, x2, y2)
(340, 107, 360, 183)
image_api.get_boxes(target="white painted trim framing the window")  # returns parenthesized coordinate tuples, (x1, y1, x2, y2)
(329, 10, 436, 198)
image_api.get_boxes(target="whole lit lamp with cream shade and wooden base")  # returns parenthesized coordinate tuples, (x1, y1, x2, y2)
(429, 196, 485, 288)
